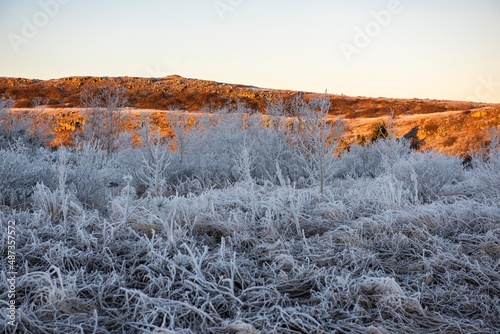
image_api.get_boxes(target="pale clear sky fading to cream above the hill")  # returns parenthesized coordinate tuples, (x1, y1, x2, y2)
(0, 0, 500, 103)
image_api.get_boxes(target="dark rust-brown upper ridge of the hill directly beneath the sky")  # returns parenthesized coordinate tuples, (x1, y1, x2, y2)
(0, 75, 488, 117)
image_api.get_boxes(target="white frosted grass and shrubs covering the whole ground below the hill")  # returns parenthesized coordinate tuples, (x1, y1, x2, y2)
(0, 95, 500, 333)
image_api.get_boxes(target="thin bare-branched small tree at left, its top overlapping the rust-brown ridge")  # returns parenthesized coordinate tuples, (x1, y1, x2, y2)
(80, 82, 127, 155)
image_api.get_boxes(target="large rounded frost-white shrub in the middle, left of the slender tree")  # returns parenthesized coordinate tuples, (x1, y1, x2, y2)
(176, 104, 324, 189)
